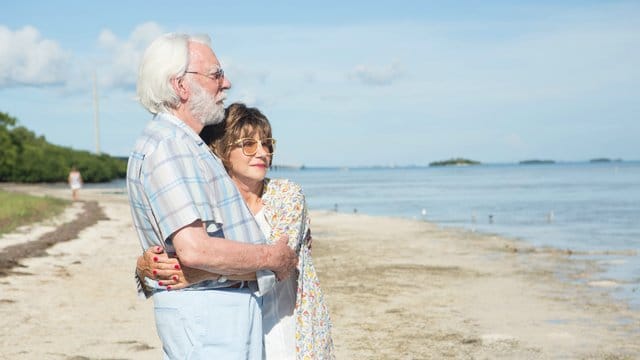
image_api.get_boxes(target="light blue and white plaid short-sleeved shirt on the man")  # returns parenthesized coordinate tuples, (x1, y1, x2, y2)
(127, 113, 275, 294)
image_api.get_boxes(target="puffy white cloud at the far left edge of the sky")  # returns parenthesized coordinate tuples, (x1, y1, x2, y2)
(0, 26, 70, 88)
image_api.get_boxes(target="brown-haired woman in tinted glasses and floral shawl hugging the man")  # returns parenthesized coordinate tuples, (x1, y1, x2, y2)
(137, 104, 333, 359)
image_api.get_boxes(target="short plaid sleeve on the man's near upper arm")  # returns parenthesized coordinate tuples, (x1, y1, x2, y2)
(142, 138, 215, 240)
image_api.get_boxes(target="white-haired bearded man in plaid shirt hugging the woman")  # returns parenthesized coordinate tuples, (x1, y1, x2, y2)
(127, 34, 297, 359)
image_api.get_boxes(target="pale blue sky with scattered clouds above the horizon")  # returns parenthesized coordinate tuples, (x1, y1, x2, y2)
(0, 0, 640, 166)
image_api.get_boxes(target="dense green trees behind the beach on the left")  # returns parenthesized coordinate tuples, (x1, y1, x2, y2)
(0, 112, 127, 183)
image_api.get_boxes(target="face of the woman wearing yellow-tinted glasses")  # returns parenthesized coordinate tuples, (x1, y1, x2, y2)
(229, 134, 271, 185)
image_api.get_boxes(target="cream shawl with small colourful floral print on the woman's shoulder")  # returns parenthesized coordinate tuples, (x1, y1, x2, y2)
(262, 179, 334, 359)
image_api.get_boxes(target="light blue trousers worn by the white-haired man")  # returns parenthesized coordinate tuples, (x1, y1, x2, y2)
(152, 288, 263, 360)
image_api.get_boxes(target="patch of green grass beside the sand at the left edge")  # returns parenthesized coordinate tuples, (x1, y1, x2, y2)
(0, 190, 69, 234)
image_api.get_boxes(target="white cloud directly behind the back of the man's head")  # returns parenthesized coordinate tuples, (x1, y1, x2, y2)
(97, 22, 164, 88)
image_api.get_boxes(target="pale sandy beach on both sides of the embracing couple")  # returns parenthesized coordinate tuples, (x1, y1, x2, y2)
(0, 184, 640, 360)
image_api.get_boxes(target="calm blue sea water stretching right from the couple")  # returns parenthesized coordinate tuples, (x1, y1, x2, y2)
(270, 162, 640, 307)
